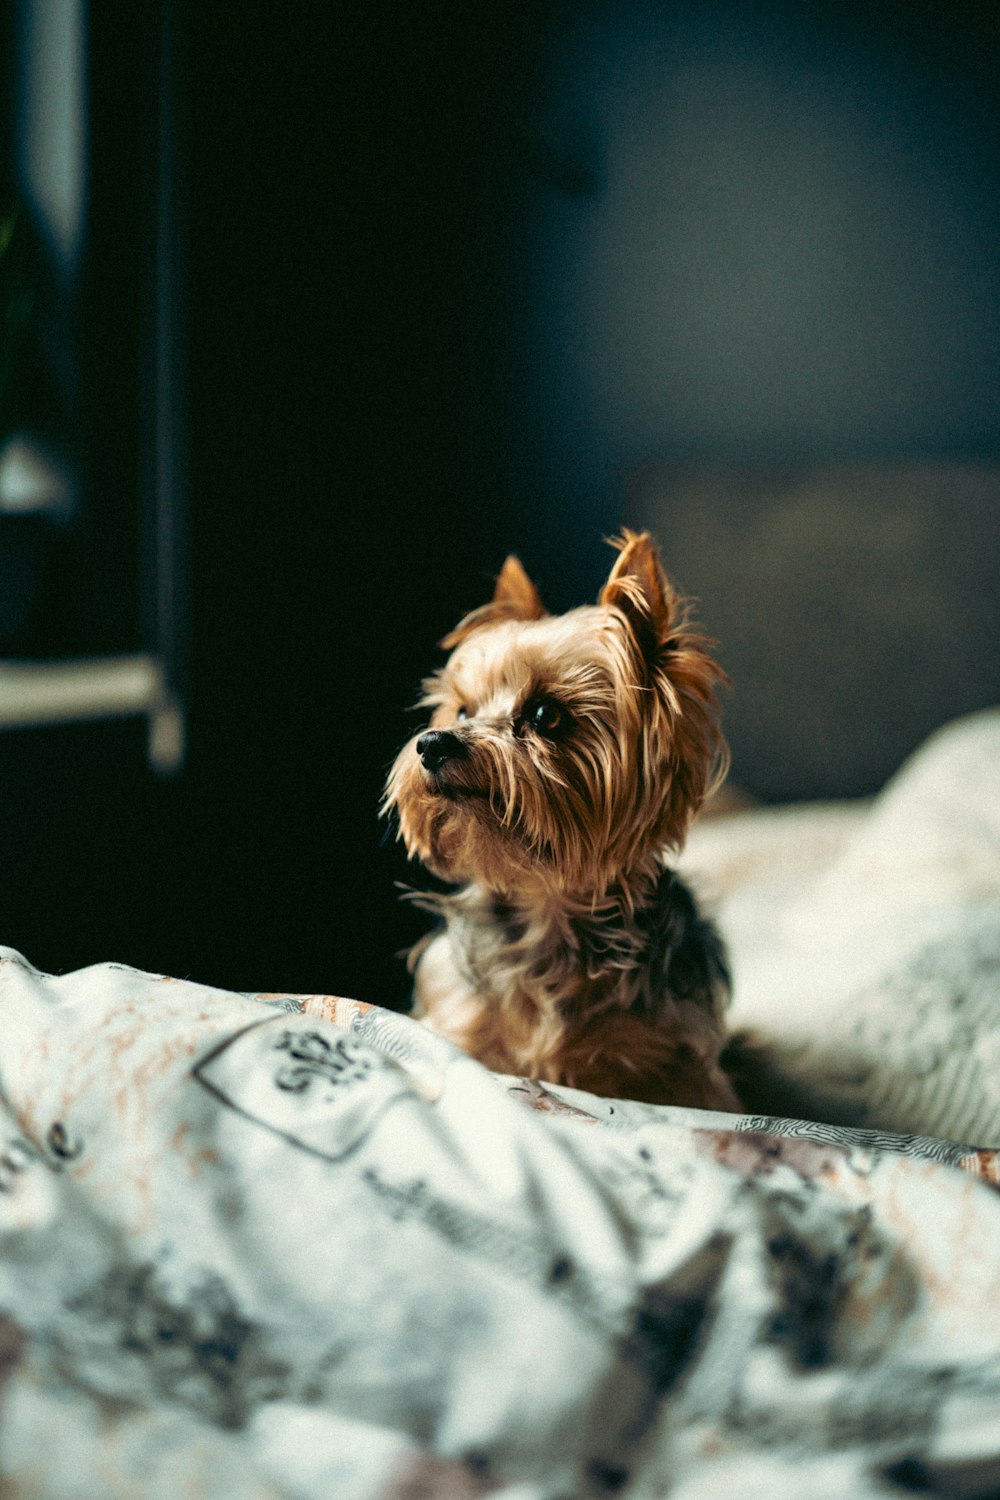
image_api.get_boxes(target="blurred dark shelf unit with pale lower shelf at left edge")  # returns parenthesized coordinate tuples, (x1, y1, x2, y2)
(0, 0, 187, 773)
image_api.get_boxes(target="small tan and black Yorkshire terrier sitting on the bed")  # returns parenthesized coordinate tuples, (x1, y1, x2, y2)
(385, 531, 739, 1110)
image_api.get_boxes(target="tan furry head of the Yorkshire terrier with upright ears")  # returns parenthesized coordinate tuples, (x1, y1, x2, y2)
(385, 531, 726, 897)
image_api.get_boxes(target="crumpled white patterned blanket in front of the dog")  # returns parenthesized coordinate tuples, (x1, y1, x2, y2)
(0, 948, 1000, 1500)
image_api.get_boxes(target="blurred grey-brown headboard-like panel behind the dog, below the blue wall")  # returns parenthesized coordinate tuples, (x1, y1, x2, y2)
(631, 461, 1000, 801)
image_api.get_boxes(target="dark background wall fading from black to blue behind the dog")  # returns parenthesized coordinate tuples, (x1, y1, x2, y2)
(0, 0, 1000, 1004)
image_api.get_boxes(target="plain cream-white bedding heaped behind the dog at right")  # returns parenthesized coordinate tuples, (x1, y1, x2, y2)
(684, 708, 1000, 1146)
